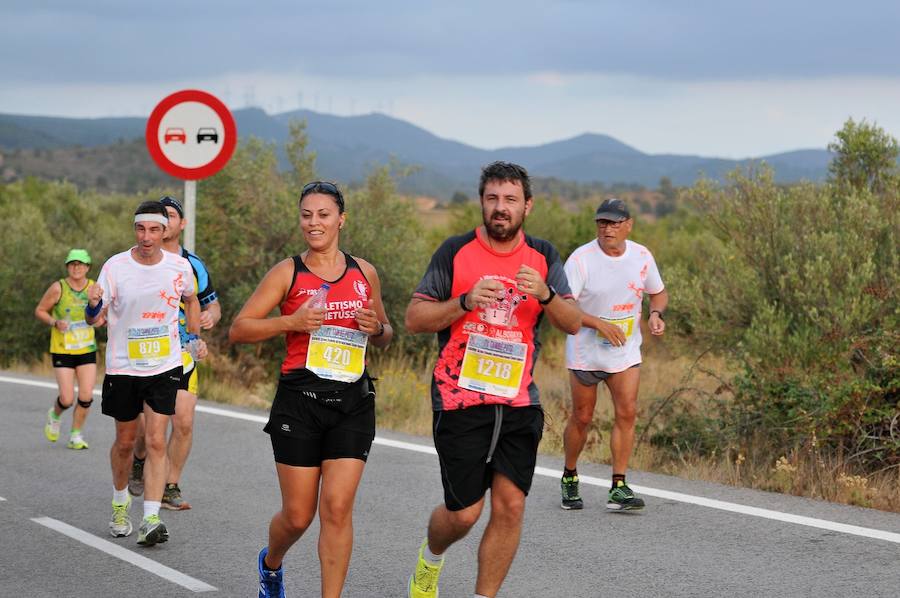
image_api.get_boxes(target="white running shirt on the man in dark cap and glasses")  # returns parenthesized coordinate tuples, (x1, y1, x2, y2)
(564, 239, 665, 374)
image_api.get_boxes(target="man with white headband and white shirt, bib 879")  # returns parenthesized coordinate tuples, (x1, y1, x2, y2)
(85, 201, 200, 546)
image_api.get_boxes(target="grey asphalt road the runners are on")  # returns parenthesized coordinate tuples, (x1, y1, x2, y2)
(0, 372, 900, 598)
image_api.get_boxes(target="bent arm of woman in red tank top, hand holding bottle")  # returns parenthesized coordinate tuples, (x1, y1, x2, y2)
(228, 259, 325, 343)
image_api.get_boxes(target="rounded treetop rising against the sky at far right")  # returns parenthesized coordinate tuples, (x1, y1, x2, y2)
(828, 118, 900, 194)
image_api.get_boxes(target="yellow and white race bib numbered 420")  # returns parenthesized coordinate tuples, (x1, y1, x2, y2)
(306, 326, 369, 382)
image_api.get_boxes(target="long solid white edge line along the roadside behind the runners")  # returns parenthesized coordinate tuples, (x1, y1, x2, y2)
(0, 376, 900, 544)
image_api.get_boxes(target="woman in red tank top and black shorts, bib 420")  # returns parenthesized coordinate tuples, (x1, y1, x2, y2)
(229, 181, 393, 597)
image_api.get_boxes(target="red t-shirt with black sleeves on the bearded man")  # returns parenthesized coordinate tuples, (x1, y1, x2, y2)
(413, 228, 571, 411)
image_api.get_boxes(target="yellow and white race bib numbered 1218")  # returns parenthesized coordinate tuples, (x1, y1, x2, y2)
(459, 333, 528, 398)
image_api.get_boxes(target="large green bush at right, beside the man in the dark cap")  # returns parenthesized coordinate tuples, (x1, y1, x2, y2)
(652, 169, 900, 470)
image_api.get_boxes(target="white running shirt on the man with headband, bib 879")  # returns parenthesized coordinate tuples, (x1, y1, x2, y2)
(97, 249, 195, 376)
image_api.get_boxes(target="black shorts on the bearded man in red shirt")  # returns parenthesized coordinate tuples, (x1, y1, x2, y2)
(432, 405, 544, 511)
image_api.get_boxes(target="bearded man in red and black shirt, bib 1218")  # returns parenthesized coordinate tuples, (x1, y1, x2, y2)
(406, 162, 581, 598)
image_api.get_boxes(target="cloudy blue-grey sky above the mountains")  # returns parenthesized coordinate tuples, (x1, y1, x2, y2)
(0, 0, 900, 158)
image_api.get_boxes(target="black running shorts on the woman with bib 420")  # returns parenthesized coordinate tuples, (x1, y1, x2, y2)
(265, 384, 375, 467)
